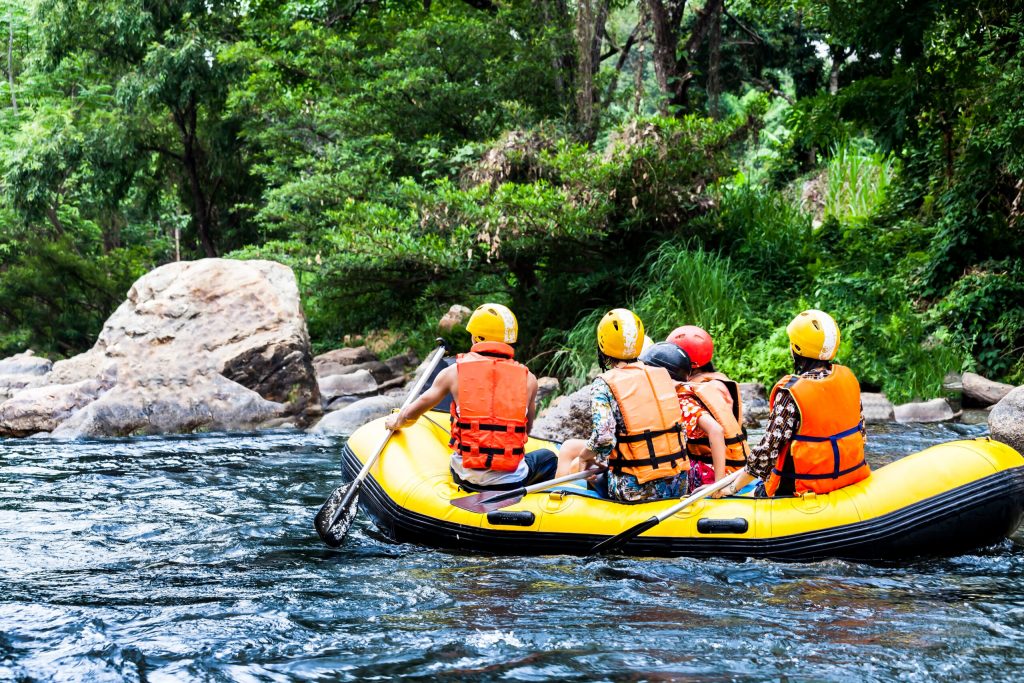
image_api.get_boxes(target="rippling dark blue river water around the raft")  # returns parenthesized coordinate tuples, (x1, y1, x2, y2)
(0, 425, 1024, 682)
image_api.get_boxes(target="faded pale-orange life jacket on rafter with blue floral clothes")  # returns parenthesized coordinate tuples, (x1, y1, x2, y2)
(601, 362, 690, 483)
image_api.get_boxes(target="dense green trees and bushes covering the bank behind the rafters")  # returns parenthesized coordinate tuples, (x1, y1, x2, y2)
(0, 0, 1024, 399)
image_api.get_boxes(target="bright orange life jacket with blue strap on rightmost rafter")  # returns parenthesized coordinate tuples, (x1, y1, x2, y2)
(765, 366, 871, 496)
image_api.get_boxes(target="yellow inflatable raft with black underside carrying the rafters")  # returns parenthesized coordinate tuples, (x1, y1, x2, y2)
(344, 413, 1024, 560)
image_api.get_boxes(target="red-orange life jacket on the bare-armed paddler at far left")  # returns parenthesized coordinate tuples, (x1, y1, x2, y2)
(449, 342, 529, 472)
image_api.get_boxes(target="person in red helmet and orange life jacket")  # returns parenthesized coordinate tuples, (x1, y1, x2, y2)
(667, 325, 750, 486)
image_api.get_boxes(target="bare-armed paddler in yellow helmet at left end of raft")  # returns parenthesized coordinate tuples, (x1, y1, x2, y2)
(385, 303, 558, 490)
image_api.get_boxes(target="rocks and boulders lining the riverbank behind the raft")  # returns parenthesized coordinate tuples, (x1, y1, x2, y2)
(0, 259, 1024, 451)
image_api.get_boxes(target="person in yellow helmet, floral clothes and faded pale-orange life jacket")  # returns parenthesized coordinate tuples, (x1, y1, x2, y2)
(558, 308, 689, 501)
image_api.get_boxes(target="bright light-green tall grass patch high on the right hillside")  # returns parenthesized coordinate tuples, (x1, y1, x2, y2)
(824, 140, 899, 221)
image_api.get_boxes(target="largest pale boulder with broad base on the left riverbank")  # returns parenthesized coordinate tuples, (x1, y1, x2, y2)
(0, 259, 321, 436)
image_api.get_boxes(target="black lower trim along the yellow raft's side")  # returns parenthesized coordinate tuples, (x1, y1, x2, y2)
(342, 444, 1024, 561)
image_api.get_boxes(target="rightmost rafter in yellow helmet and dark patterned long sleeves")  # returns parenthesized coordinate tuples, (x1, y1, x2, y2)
(726, 309, 871, 496)
